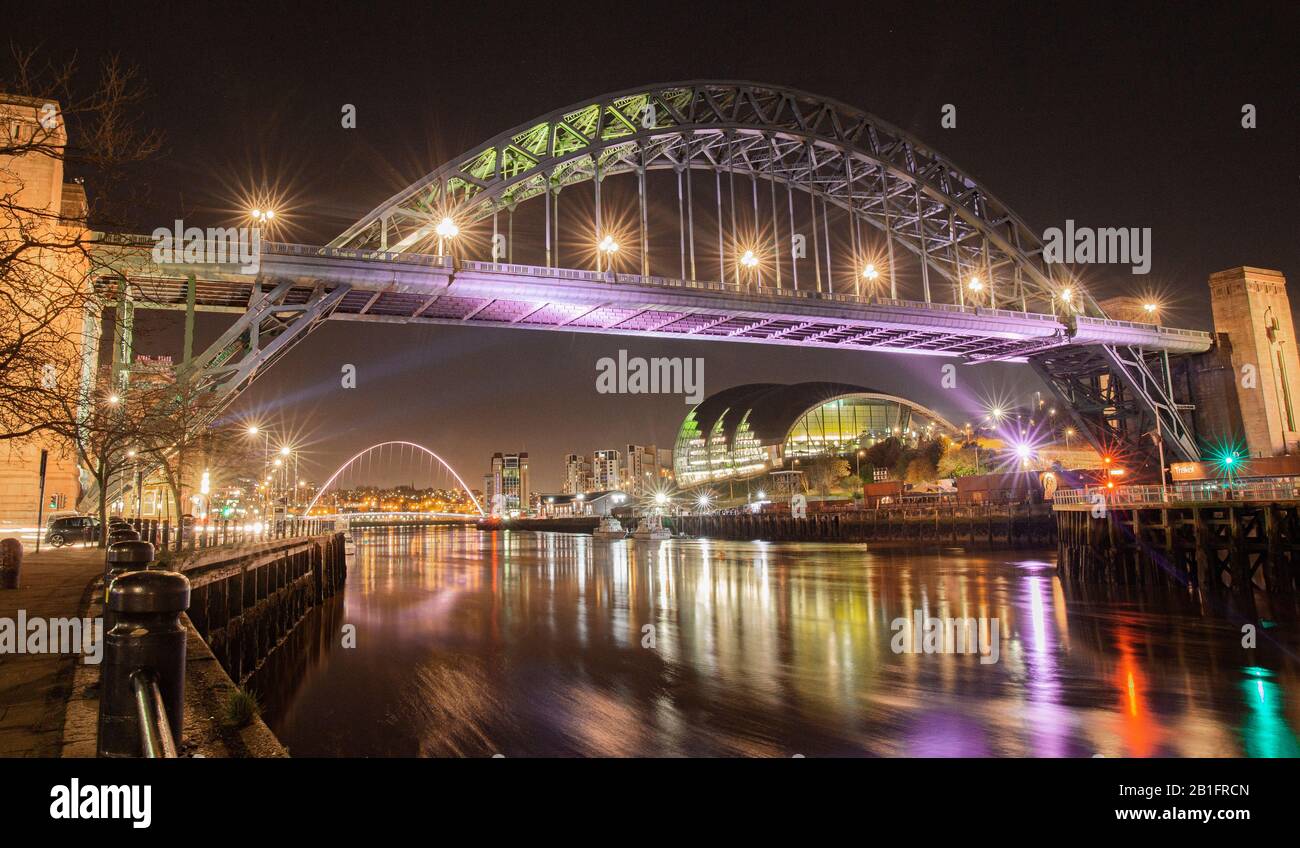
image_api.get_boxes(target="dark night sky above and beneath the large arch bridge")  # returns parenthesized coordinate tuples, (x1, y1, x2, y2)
(5, 1, 1300, 489)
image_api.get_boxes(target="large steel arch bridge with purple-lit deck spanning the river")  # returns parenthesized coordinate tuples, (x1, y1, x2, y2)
(86, 81, 1210, 476)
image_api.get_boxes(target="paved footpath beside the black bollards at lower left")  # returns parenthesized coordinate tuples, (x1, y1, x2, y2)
(0, 545, 104, 757)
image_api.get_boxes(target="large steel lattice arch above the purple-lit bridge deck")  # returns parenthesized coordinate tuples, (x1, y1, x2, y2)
(332, 81, 1105, 317)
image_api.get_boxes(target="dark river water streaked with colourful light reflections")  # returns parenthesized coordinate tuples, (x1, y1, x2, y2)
(252, 528, 1300, 757)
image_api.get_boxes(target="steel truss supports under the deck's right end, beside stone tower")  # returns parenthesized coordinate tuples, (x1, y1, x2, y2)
(1028, 345, 1200, 467)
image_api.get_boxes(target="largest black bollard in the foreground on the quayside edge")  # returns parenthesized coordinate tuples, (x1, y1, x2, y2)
(99, 569, 190, 757)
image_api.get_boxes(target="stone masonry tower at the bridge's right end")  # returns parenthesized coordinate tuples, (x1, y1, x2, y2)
(1210, 267, 1300, 457)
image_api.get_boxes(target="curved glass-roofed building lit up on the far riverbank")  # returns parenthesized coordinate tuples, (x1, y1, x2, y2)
(672, 382, 957, 488)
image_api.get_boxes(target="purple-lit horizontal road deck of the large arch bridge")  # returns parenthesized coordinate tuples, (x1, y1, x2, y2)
(96, 239, 1210, 359)
